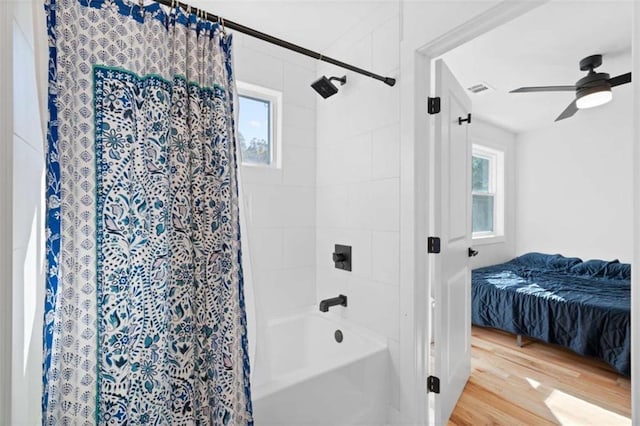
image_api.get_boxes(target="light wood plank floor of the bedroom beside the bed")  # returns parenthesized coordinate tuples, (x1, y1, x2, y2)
(449, 327, 631, 426)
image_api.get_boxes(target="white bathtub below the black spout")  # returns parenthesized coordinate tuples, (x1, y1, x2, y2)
(252, 308, 389, 426)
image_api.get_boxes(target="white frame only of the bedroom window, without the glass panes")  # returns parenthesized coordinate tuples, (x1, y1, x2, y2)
(471, 143, 505, 244)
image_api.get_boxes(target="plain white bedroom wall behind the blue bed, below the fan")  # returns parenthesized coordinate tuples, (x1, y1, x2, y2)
(516, 85, 634, 262)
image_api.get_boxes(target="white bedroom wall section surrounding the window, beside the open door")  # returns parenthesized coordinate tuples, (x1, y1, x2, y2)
(469, 118, 517, 268)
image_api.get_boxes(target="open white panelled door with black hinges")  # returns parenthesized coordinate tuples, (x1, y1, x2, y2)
(429, 60, 471, 425)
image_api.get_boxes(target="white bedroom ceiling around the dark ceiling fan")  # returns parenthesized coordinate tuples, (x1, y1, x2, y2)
(443, 0, 633, 133)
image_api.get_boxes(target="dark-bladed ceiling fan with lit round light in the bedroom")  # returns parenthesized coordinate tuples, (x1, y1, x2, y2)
(509, 55, 631, 121)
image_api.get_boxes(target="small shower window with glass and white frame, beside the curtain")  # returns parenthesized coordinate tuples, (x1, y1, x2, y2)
(237, 82, 282, 167)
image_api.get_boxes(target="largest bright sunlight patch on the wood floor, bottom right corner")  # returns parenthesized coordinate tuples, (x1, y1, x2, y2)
(545, 390, 631, 426)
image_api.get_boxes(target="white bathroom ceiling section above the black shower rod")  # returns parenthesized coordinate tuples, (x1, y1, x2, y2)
(189, 0, 388, 52)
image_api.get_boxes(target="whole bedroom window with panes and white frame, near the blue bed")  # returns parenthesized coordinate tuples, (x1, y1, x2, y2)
(471, 145, 504, 239)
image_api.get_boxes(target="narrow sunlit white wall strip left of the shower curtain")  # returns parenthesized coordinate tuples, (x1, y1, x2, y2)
(11, 2, 44, 425)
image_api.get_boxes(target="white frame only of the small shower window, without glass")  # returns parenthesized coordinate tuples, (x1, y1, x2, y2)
(236, 81, 282, 169)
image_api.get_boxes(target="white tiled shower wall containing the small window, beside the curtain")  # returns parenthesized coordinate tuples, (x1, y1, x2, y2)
(234, 33, 316, 321)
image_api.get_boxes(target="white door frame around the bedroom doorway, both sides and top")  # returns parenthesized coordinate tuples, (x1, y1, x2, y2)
(408, 0, 640, 425)
